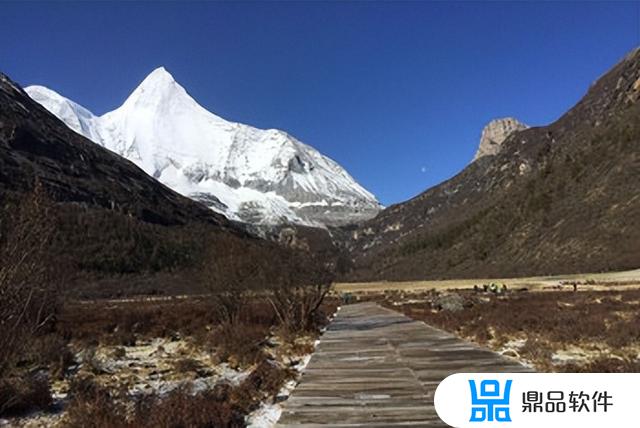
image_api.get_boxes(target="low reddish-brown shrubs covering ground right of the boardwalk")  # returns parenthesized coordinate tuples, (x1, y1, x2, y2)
(384, 290, 640, 371)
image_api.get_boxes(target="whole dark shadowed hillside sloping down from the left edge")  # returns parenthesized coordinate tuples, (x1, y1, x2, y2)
(0, 74, 298, 294)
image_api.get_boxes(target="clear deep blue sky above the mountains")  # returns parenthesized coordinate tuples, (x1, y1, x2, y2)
(0, 2, 640, 204)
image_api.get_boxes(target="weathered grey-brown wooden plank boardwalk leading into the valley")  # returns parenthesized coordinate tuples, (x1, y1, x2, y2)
(278, 303, 529, 428)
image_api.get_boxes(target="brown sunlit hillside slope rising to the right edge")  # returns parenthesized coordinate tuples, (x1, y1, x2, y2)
(347, 49, 640, 280)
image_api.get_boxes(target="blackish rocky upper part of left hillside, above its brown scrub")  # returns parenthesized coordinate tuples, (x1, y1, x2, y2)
(0, 74, 231, 229)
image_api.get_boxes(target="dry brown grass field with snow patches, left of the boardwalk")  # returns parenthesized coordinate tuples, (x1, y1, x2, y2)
(0, 296, 336, 428)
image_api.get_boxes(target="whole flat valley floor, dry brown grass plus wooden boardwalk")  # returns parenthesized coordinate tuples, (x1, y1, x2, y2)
(0, 270, 640, 427)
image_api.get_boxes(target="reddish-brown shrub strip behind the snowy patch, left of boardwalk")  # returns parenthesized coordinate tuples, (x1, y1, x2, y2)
(57, 296, 275, 365)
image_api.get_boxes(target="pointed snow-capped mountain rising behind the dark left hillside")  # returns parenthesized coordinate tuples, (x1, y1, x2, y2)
(25, 67, 381, 226)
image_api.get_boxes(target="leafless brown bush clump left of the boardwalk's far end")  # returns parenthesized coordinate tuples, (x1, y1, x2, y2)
(203, 234, 333, 358)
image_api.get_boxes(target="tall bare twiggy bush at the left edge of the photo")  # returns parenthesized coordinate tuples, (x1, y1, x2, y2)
(0, 184, 60, 414)
